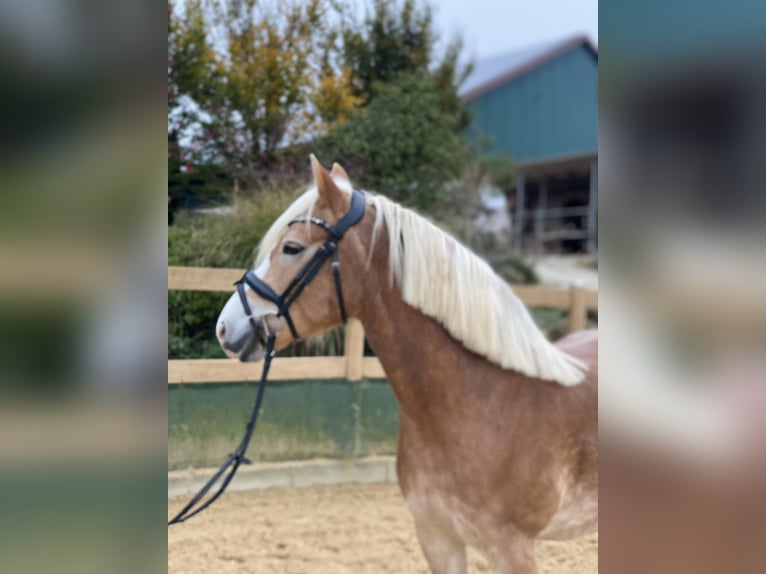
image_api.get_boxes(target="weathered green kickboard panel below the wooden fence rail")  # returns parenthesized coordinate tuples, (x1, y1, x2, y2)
(168, 379, 399, 470)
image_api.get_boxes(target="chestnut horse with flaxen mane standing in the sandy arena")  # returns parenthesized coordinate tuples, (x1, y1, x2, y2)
(217, 156, 598, 574)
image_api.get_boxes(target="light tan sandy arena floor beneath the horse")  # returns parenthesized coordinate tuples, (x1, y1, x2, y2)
(168, 484, 598, 574)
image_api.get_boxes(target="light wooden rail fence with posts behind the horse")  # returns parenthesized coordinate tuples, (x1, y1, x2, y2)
(168, 267, 598, 384)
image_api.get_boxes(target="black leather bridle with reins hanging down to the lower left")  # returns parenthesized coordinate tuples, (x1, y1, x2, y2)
(168, 191, 365, 525)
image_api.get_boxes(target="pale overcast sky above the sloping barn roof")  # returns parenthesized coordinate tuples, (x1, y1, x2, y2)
(431, 0, 598, 59)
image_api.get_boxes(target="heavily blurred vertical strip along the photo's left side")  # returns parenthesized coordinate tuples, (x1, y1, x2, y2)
(0, 0, 167, 572)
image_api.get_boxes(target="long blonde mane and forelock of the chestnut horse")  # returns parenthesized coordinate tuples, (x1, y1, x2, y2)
(256, 178, 586, 386)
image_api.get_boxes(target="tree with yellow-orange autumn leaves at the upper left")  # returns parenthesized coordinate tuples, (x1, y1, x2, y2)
(168, 0, 361, 186)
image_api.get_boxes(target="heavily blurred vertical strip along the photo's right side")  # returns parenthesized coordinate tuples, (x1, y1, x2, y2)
(599, 1, 766, 573)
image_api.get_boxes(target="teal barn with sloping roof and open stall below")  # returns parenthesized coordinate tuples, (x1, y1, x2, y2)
(460, 36, 598, 253)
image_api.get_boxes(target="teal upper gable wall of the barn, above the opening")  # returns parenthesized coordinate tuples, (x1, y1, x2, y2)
(472, 46, 598, 161)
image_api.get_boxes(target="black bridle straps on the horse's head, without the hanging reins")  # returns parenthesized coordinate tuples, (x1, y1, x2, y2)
(235, 191, 365, 344)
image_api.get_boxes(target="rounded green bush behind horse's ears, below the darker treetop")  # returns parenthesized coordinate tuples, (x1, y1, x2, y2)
(317, 75, 470, 209)
